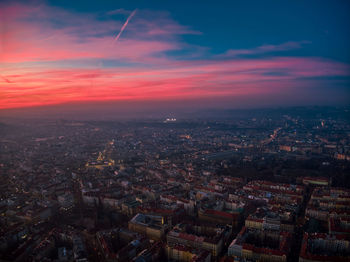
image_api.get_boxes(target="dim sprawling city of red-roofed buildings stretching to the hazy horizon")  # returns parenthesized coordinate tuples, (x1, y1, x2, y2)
(0, 108, 350, 261)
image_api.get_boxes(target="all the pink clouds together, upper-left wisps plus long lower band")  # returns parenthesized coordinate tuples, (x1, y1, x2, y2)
(0, 2, 349, 109)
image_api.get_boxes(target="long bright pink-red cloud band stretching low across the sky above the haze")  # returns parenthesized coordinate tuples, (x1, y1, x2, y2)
(0, 58, 347, 108)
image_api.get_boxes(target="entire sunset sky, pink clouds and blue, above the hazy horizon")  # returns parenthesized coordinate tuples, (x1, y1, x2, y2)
(0, 0, 350, 114)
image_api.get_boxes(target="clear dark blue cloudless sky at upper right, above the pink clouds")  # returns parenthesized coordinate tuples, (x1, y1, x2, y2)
(48, 0, 350, 63)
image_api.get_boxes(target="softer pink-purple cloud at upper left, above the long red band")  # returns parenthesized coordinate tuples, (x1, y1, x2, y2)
(0, 3, 185, 62)
